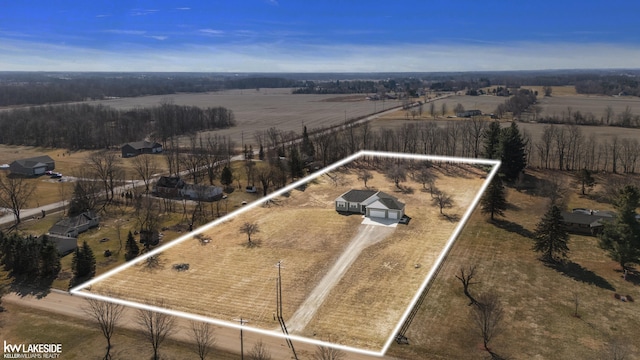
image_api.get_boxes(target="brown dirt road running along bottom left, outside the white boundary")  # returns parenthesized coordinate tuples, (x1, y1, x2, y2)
(2, 290, 398, 360)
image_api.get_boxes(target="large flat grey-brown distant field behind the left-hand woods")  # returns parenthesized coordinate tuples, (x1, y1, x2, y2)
(79, 89, 401, 149)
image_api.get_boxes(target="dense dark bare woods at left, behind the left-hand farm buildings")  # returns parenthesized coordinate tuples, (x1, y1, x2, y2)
(0, 103, 235, 150)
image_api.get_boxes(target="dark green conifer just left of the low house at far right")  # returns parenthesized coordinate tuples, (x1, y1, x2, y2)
(533, 205, 569, 262)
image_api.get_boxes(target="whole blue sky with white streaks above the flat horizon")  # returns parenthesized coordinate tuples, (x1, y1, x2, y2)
(0, 0, 640, 72)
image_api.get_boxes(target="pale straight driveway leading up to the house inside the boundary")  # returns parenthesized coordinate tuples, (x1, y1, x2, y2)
(287, 225, 395, 334)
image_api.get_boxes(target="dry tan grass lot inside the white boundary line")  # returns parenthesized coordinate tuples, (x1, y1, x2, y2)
(82, 157, 484, 351)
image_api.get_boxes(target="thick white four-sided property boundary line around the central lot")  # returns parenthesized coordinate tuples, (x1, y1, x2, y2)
(69, 150, 500, 357)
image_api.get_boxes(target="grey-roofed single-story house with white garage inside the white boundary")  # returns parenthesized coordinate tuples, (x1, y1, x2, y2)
(335, 190, 404, 220)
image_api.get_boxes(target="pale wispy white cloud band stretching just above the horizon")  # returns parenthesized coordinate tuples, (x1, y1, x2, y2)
(0, 38, 640, 72)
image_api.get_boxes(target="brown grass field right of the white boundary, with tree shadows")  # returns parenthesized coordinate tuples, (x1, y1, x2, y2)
(387, 171, 640, 359)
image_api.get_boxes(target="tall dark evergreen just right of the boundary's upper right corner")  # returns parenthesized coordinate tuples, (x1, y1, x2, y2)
(500, 122, 527, 181)
